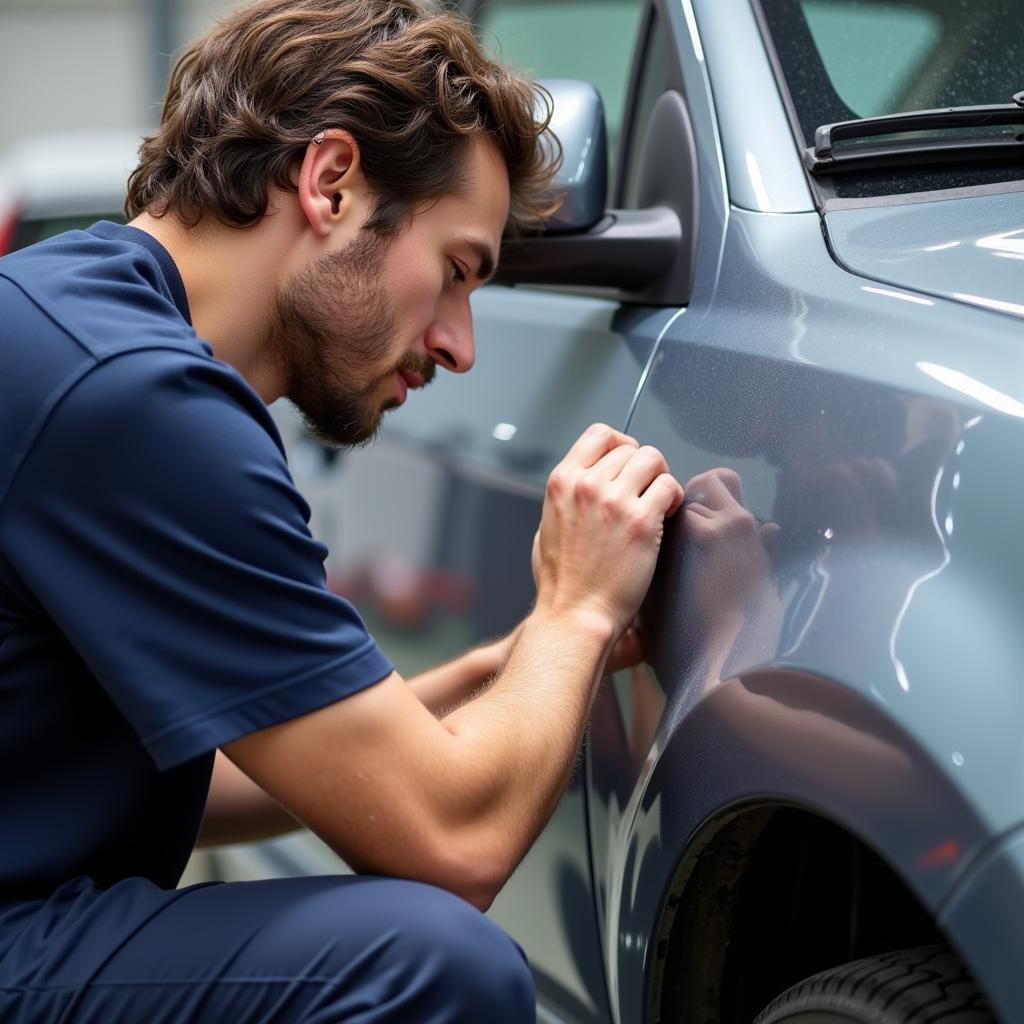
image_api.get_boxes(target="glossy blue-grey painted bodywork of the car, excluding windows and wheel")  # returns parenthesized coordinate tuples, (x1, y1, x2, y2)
(218, 0, 1024, 1024)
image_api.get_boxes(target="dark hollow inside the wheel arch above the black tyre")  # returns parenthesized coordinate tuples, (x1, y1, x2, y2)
(647, 801, 949, 1024)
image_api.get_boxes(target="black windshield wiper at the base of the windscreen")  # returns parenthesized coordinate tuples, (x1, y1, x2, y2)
(804, 92, 1024, 174)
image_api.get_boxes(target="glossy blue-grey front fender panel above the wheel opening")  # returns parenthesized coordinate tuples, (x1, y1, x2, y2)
(591, 201, 1024, 1020)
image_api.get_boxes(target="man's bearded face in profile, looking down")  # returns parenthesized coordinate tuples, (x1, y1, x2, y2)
(268, 140, 509, 445)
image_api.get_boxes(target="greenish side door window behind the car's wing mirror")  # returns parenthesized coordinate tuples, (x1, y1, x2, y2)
(476, 0, 644, 180)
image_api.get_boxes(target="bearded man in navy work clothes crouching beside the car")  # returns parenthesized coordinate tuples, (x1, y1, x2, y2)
(0, 0, 682, 1022)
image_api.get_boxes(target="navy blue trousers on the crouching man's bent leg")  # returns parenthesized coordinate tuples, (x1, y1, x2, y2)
(0, 876, 535, 1024)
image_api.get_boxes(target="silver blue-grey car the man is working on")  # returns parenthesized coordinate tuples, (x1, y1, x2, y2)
(216, 0, 1024, 1024)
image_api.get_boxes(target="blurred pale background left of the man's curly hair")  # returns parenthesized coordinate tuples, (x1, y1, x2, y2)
(0, 0, 238, 255)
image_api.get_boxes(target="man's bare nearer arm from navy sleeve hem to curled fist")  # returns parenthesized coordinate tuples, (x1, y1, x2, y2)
(224, 426, 682, 907)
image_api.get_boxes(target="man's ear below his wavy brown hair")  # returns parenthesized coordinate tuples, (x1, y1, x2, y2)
(298, 128, 366, 238)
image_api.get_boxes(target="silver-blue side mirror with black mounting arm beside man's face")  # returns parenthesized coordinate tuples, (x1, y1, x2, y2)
(495, 79, 693, 304)
